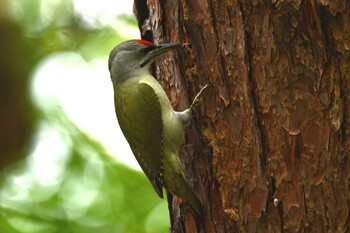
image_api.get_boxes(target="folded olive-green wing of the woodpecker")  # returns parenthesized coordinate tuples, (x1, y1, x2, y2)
(115, 82, 163, 198)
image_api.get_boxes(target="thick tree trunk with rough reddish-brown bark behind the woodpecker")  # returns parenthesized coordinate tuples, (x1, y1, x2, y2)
(135, 0, 350, 232)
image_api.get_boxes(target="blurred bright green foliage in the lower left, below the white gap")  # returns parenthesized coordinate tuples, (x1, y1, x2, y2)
(0, 112, 169, 233)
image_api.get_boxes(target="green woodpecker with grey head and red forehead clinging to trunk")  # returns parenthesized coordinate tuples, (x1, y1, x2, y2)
(108, 39, 209, 232)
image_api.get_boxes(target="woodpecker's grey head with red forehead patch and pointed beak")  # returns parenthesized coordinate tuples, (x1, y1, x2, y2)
(108, 40, 180, 83)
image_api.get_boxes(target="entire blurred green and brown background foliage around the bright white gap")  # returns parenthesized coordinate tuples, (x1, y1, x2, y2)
(0, 0, 169, 233)
